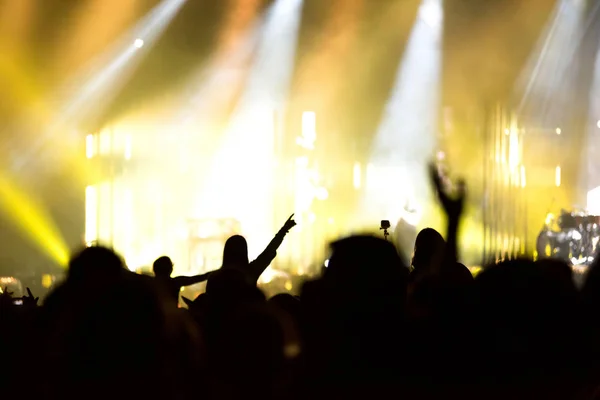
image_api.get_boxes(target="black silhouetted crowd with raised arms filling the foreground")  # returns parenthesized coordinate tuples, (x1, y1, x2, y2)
(0, 163, 600, 400)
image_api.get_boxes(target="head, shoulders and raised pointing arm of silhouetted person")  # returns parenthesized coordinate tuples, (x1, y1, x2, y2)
(221, 214, 296, 284)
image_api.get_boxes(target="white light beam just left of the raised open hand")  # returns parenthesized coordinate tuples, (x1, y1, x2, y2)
(361, 0, 443, 225)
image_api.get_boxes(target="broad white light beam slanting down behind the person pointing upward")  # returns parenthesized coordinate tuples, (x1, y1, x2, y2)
(197, 0, 302, 254)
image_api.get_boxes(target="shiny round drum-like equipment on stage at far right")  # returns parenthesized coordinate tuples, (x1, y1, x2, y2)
(536, 210, 600, 264)
